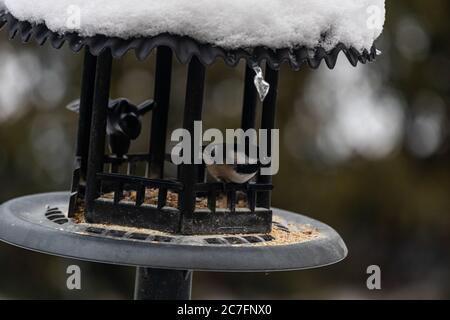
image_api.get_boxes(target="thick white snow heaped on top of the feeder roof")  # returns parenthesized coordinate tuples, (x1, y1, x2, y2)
(0, 0, 385, 50)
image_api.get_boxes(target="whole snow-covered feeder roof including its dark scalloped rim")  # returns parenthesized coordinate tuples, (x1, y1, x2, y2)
(0, 0, 385, 69)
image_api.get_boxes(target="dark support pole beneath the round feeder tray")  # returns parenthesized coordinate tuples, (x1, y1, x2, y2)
(134, 267, 192, 300)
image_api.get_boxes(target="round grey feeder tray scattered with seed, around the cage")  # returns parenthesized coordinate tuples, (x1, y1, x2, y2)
(0, 192, 347, 272)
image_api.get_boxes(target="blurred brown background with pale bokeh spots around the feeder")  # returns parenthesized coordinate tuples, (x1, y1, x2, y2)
(0, 0, 450, 299)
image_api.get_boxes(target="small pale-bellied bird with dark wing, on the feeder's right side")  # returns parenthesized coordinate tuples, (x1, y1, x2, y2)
(205, 143, 261, 184)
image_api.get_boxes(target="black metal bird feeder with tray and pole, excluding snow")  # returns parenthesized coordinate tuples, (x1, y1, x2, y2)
(0, 12, 376, 299)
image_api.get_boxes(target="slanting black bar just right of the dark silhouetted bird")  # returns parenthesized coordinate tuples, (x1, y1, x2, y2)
(147, 47, 173, 178)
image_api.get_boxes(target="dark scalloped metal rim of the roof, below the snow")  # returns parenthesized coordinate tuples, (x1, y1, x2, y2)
(0, 12, 377, 71)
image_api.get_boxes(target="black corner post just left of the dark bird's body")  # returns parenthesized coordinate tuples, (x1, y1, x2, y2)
(86, 50, 112, 221)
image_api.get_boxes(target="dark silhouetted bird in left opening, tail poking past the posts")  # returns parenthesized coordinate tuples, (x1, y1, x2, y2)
(67, 98, 155, 158)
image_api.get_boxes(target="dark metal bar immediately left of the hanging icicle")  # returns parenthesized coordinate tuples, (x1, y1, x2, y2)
(241, 64, 257, 130)
